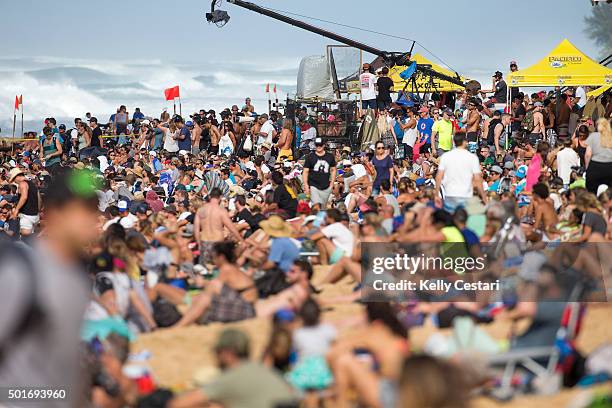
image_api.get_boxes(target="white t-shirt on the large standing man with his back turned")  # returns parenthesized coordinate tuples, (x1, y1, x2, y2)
(438, 148, 480, 198)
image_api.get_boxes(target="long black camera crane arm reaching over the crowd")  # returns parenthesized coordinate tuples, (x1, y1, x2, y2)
(206, 0, 466, 87)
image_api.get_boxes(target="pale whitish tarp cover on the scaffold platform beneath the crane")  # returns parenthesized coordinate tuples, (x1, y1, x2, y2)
(297, 55, 334, 99)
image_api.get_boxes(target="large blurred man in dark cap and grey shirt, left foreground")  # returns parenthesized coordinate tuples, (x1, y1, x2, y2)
(0, 172, 99, 408)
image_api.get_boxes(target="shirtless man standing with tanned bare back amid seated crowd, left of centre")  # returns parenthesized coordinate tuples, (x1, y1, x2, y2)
(193, 188, 242, 265)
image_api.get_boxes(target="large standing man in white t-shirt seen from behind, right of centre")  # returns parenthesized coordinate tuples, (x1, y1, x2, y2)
(436, 133, 487, 213)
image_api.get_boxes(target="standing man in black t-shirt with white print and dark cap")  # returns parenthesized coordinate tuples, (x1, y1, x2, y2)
(302, 138, 336, 209)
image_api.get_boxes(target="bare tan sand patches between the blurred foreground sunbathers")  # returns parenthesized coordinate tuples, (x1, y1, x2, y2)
(133, 267, 612, 408)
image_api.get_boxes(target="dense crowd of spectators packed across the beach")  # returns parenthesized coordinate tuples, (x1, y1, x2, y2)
(0, 62, 612, 408)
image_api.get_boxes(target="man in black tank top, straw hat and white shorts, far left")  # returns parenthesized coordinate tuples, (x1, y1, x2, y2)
(9, 168, 40, 237)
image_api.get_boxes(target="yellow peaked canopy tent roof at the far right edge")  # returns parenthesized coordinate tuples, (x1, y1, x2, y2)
(507, 39, 612, 87)
